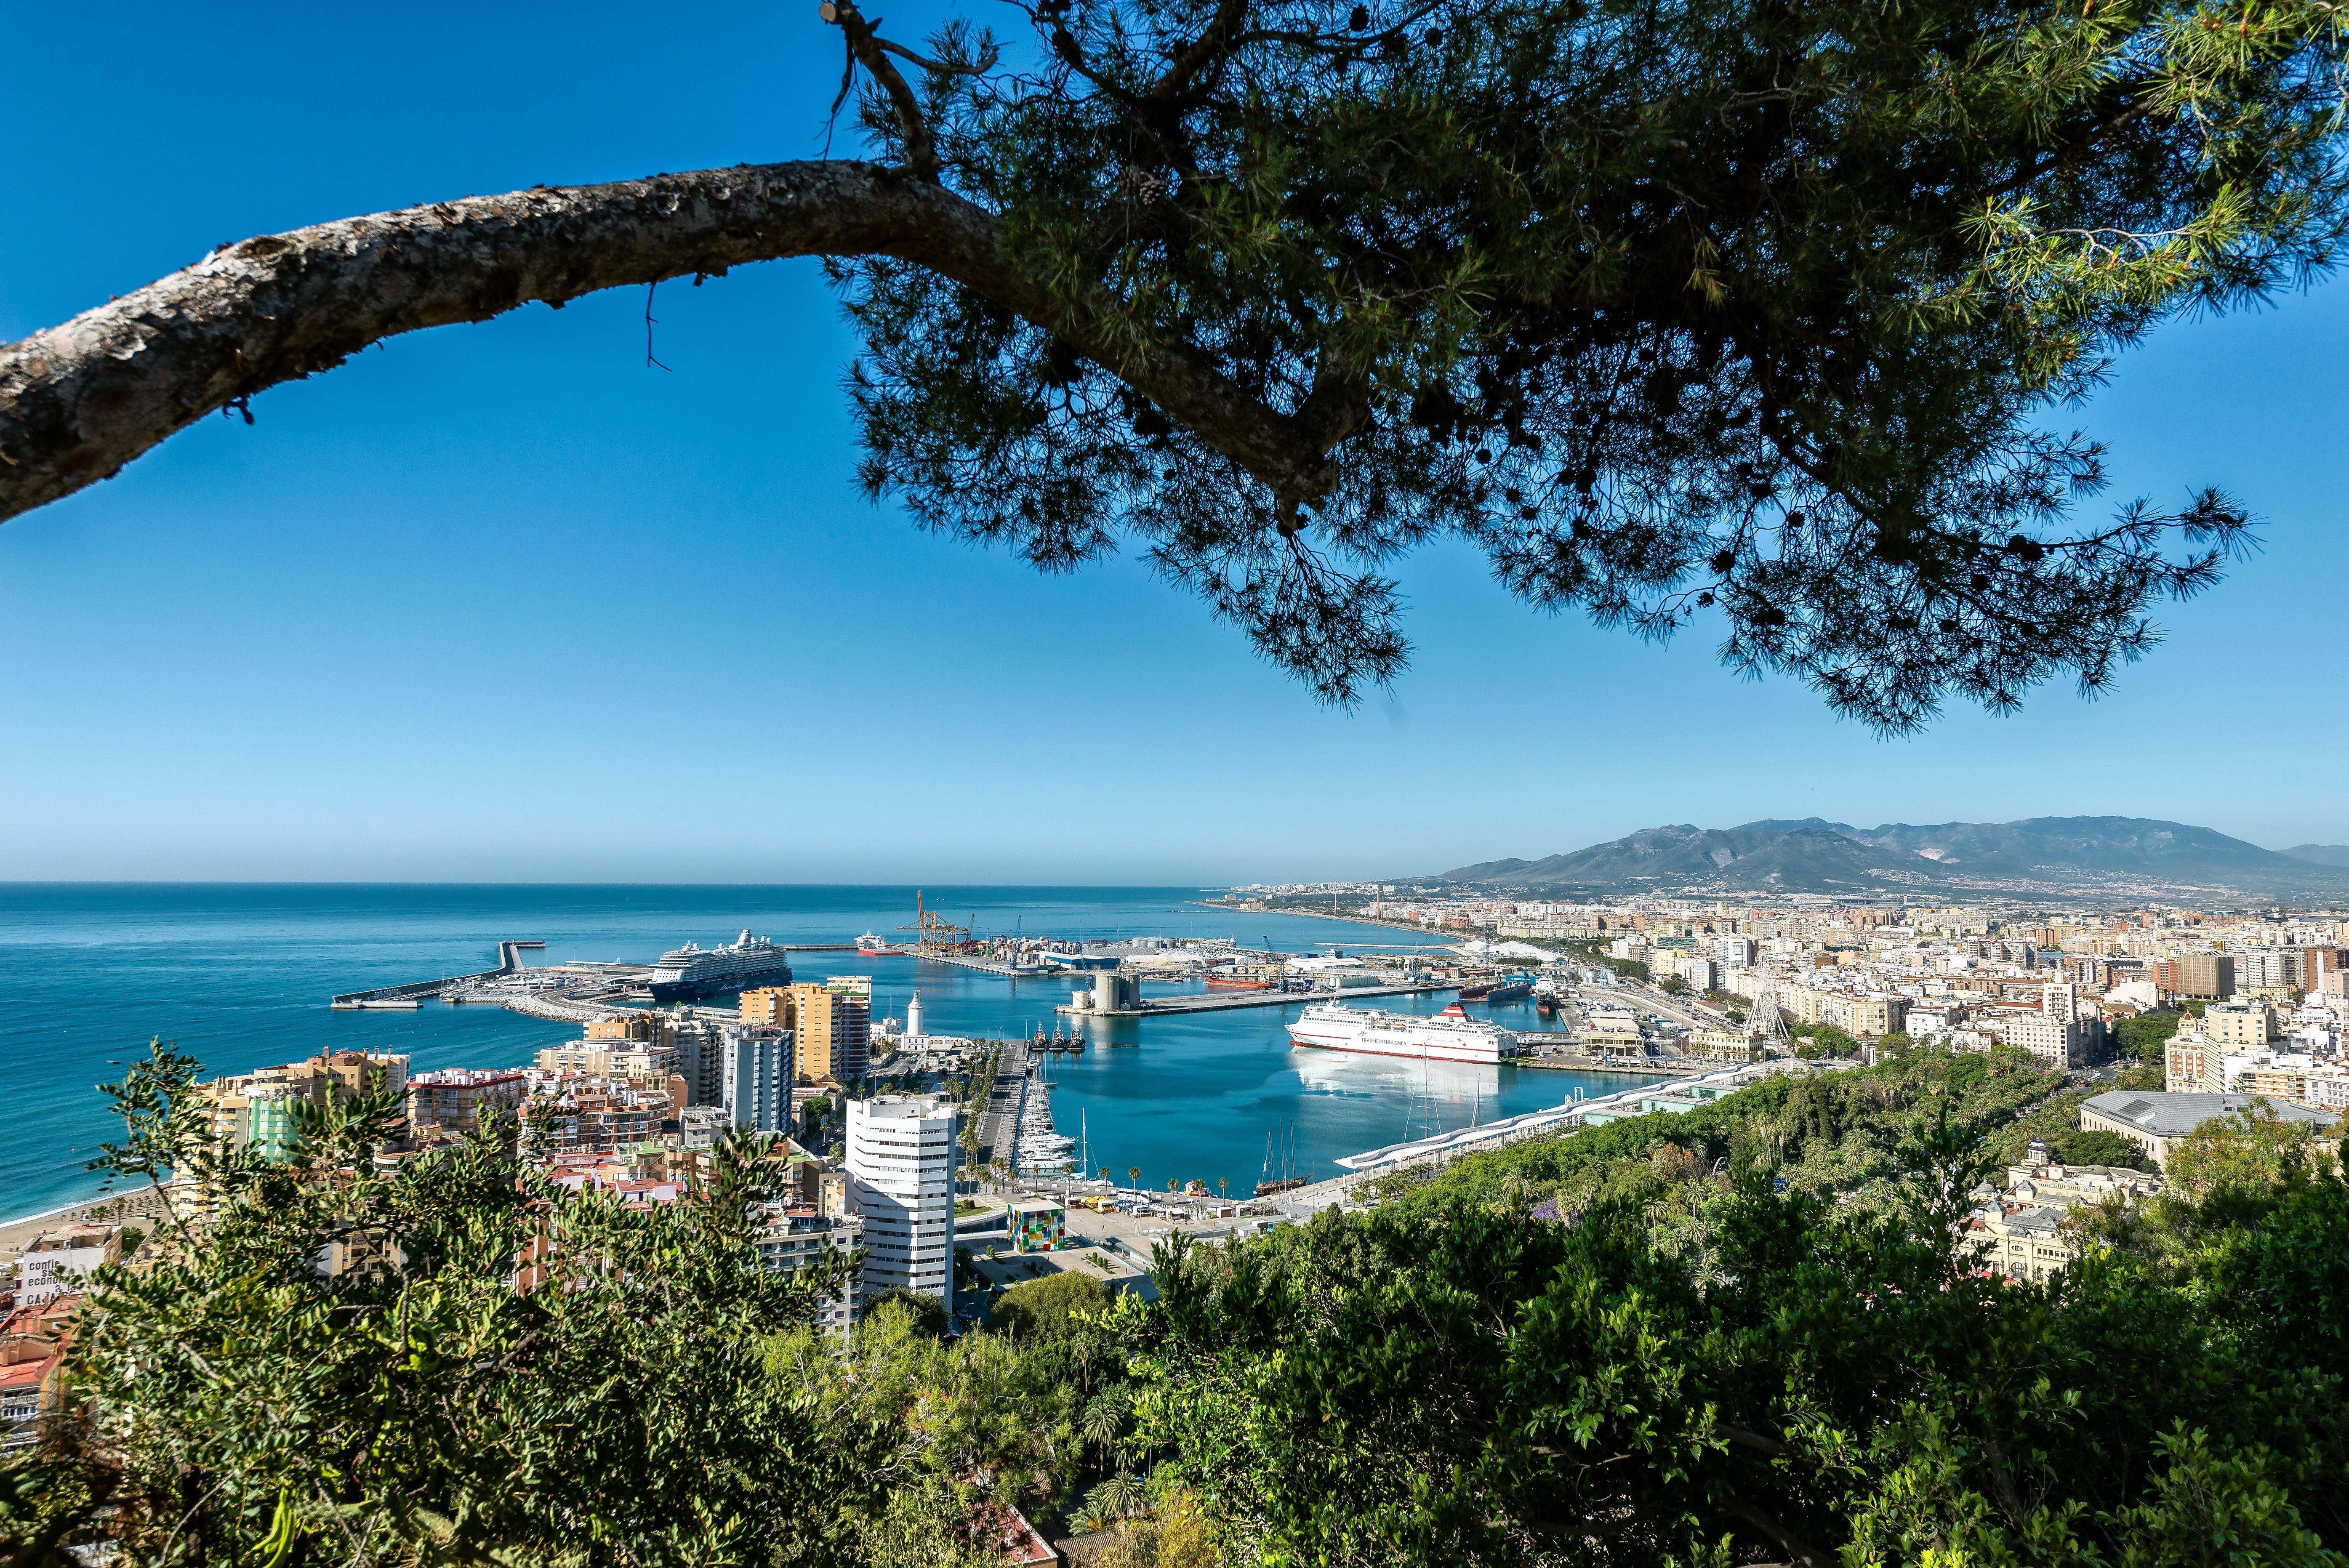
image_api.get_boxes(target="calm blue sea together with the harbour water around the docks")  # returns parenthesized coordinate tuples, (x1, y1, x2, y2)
(0, 883, 1654, 1218)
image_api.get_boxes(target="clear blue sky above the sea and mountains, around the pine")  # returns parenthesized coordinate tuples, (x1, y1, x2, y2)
(0, 3, 2349, 883)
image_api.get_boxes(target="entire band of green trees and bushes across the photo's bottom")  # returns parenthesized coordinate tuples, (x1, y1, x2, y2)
(0, 1033, 2349, 1568)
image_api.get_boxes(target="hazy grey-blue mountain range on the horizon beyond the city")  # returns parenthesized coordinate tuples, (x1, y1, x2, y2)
(1435, 817, 2349, 899)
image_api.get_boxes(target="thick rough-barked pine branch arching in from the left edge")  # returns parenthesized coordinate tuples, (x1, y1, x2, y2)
(0, 162, 1332, 521)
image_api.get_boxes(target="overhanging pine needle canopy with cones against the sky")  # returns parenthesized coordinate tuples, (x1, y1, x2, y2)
(836, 0, 2344, 728)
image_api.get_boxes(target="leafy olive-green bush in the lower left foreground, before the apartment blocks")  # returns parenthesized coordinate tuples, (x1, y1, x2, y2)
(12, 1047, 886, 1565)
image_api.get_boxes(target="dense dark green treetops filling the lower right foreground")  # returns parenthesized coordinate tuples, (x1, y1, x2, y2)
(1142, 1139, 2349, 1568)
